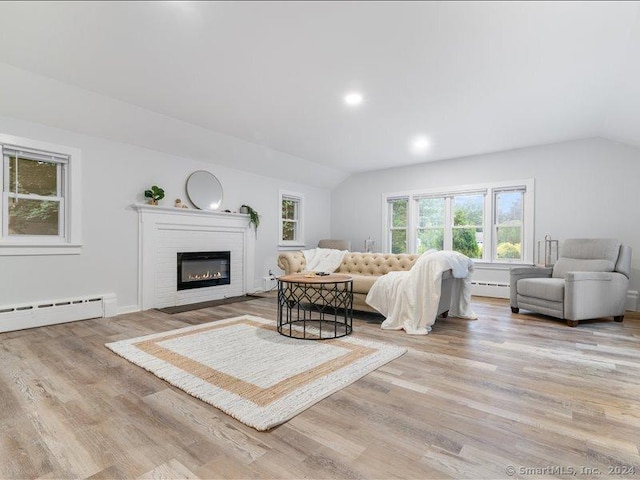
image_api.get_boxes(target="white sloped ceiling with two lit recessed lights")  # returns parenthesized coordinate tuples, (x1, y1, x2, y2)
(0, 2, 640, 180)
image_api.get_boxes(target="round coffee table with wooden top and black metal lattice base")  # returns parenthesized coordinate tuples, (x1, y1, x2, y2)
(278, 273, 353, 340)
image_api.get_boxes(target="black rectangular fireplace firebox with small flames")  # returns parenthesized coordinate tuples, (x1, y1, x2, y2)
(178, 252, 231, 290)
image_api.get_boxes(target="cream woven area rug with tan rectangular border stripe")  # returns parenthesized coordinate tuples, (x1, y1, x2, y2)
(106, 315, 407, 430)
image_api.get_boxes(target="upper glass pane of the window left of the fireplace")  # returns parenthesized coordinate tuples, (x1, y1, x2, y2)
(9, 157, 58, 196)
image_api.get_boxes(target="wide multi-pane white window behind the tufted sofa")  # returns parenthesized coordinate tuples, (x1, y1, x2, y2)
(384, 180, 533, 263)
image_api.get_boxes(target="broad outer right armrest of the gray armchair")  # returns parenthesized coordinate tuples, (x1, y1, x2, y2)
(564, 272, 629, 320)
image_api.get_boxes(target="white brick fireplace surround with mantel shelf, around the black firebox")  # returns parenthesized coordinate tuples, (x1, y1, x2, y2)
(132, 204, 255, 310)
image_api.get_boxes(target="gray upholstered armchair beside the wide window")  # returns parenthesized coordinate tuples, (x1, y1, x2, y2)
(510, 239, 631, 327)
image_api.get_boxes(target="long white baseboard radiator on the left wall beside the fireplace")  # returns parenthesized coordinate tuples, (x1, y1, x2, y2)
(0, 293, 118, 332)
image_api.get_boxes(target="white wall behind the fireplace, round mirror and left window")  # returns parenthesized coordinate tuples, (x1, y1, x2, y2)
(0, 116, 331, 311)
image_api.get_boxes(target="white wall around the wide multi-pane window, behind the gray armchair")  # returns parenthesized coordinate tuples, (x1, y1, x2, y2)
(331, 138, 640, 296)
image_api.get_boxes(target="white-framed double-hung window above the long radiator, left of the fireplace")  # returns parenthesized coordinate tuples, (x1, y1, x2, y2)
(0, 135, 80, 255)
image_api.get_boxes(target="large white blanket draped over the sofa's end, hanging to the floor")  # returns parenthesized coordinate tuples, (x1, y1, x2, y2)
(366, 250, 477, 335)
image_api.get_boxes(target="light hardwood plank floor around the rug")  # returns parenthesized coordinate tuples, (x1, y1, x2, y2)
(0, 298, 640, 479)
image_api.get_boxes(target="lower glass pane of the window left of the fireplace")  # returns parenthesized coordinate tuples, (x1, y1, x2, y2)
(9, 198, 60, 235)
